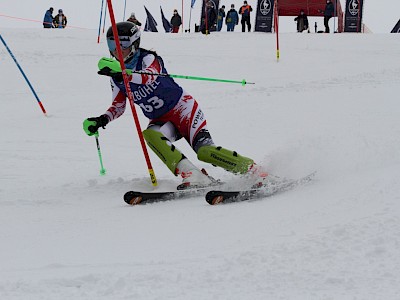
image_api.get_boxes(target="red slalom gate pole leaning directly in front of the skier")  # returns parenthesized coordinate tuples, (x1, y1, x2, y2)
(107, 0, 157, 186)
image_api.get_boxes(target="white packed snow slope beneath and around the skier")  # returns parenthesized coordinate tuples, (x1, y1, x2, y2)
(0, 29, 400, 300)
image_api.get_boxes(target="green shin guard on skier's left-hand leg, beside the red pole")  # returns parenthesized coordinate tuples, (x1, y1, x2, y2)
(143, 129, 184, 175)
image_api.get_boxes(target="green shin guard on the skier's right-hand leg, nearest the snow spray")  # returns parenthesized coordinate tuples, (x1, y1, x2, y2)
(197, 146, 254, 174)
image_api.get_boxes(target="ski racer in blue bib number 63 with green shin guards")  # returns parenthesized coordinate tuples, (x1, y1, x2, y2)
(83, 22, 267, 188)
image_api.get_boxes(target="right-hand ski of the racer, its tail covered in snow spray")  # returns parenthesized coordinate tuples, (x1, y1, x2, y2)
(206, 172, 316, 205)
